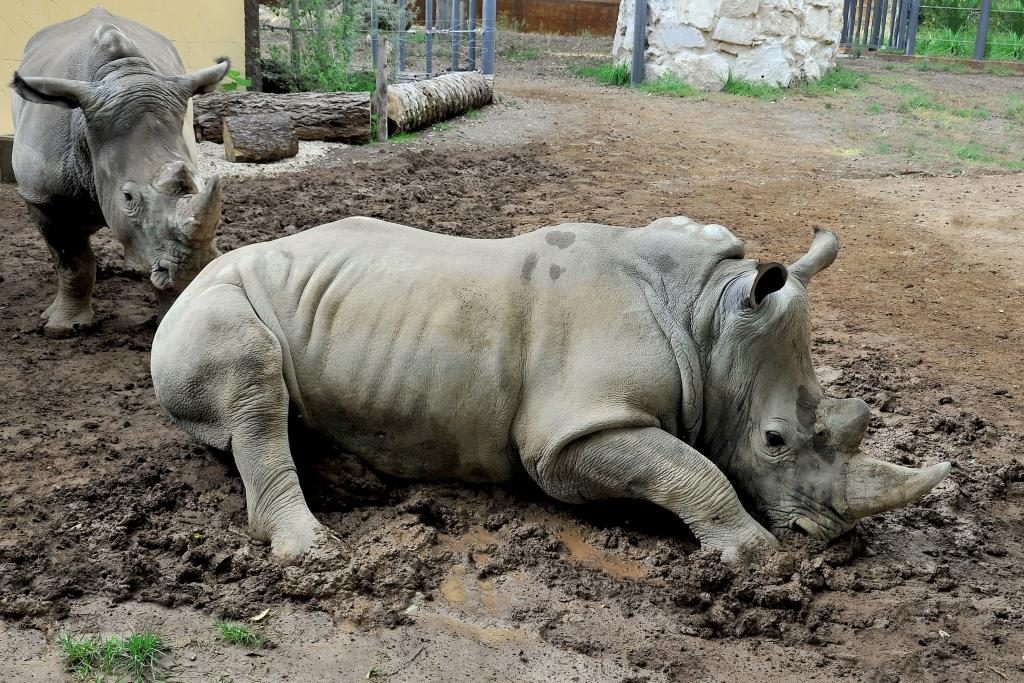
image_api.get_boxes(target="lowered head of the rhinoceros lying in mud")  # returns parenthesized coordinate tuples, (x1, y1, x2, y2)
(701, 230, 949, 540)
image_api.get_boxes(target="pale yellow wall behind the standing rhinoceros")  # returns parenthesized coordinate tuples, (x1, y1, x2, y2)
(0, 0, 245, 135)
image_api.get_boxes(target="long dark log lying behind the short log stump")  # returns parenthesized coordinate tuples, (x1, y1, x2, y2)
(193, 90, 370, 144)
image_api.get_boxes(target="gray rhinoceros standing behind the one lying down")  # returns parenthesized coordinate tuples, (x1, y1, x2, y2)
(11, 7, 229, 337)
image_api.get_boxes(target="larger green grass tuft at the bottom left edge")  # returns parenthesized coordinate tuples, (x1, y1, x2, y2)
(57, 631, 169, 683)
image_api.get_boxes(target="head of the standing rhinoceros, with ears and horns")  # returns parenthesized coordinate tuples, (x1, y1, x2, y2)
(12, 26, 230, 293)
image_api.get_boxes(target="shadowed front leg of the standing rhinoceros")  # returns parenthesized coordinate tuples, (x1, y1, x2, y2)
(29, 204, 96, 338)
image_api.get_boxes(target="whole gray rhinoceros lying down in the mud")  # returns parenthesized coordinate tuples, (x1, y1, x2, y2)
(152, 217, 949, 560)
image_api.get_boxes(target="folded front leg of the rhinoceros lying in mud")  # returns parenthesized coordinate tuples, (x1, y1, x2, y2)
(526, 428, 778, 561)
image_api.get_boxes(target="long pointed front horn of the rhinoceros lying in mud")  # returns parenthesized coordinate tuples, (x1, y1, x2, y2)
(837, 455, 949, 520)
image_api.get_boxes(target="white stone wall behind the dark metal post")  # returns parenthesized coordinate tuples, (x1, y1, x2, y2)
(612, 0, 843, 90)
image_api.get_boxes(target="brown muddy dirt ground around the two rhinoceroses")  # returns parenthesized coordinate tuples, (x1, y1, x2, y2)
(0, 39, 1024, 683)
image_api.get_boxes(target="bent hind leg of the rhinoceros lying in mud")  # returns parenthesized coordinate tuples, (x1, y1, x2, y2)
(152, 285, 329, 562)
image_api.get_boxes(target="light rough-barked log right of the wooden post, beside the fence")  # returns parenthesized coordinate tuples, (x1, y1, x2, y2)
(387, 72, 494, 135)
